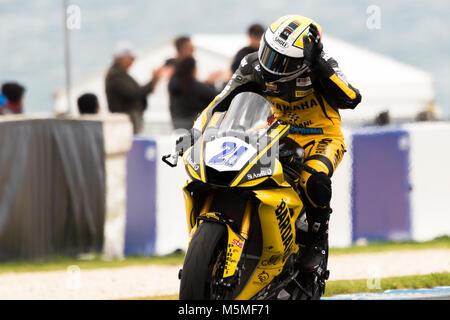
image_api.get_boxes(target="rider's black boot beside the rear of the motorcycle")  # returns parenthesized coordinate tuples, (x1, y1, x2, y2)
(299, 207, 332, 271)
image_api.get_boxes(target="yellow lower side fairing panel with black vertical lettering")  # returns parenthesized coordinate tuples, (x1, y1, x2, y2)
(236, 188, 303, 300)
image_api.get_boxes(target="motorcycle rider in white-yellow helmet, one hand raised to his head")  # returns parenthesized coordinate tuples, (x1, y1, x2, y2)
(178, 15, 361, 271)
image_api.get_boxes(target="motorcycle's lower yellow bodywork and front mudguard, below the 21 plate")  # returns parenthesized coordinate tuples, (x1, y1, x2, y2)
(183, 170, 303, 299)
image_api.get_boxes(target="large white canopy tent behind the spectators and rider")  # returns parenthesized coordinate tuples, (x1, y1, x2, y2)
(54, 34, 435, 132)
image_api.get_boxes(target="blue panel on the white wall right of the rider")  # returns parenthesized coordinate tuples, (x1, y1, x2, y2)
(352, 128, 411, 242)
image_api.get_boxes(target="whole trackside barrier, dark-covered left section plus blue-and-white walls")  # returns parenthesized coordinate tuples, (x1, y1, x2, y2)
(0, 115, 450, 260)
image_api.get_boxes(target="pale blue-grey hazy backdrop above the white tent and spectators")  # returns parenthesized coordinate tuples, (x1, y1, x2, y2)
(0, 0, 450, 118)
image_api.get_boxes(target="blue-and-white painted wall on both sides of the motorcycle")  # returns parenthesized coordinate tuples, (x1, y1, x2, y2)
(127, 123, 450, 254)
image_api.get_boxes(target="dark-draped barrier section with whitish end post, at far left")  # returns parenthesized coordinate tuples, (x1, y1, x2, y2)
(0, 115, 132, 261)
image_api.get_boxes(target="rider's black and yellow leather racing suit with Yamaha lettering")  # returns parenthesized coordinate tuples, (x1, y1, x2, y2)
(194, 52, 361, 207)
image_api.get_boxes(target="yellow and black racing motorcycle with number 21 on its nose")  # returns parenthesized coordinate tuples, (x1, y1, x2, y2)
(163, 92, 329, 300)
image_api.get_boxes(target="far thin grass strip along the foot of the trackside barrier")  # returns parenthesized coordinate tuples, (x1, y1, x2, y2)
(0, 236, 450, 274)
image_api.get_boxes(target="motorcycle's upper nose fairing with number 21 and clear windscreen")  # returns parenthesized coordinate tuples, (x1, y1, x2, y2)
(183, 93, 290, 187)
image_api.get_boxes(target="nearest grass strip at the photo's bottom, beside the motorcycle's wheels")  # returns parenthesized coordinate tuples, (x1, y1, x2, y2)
(128, 272, 450, 300)
